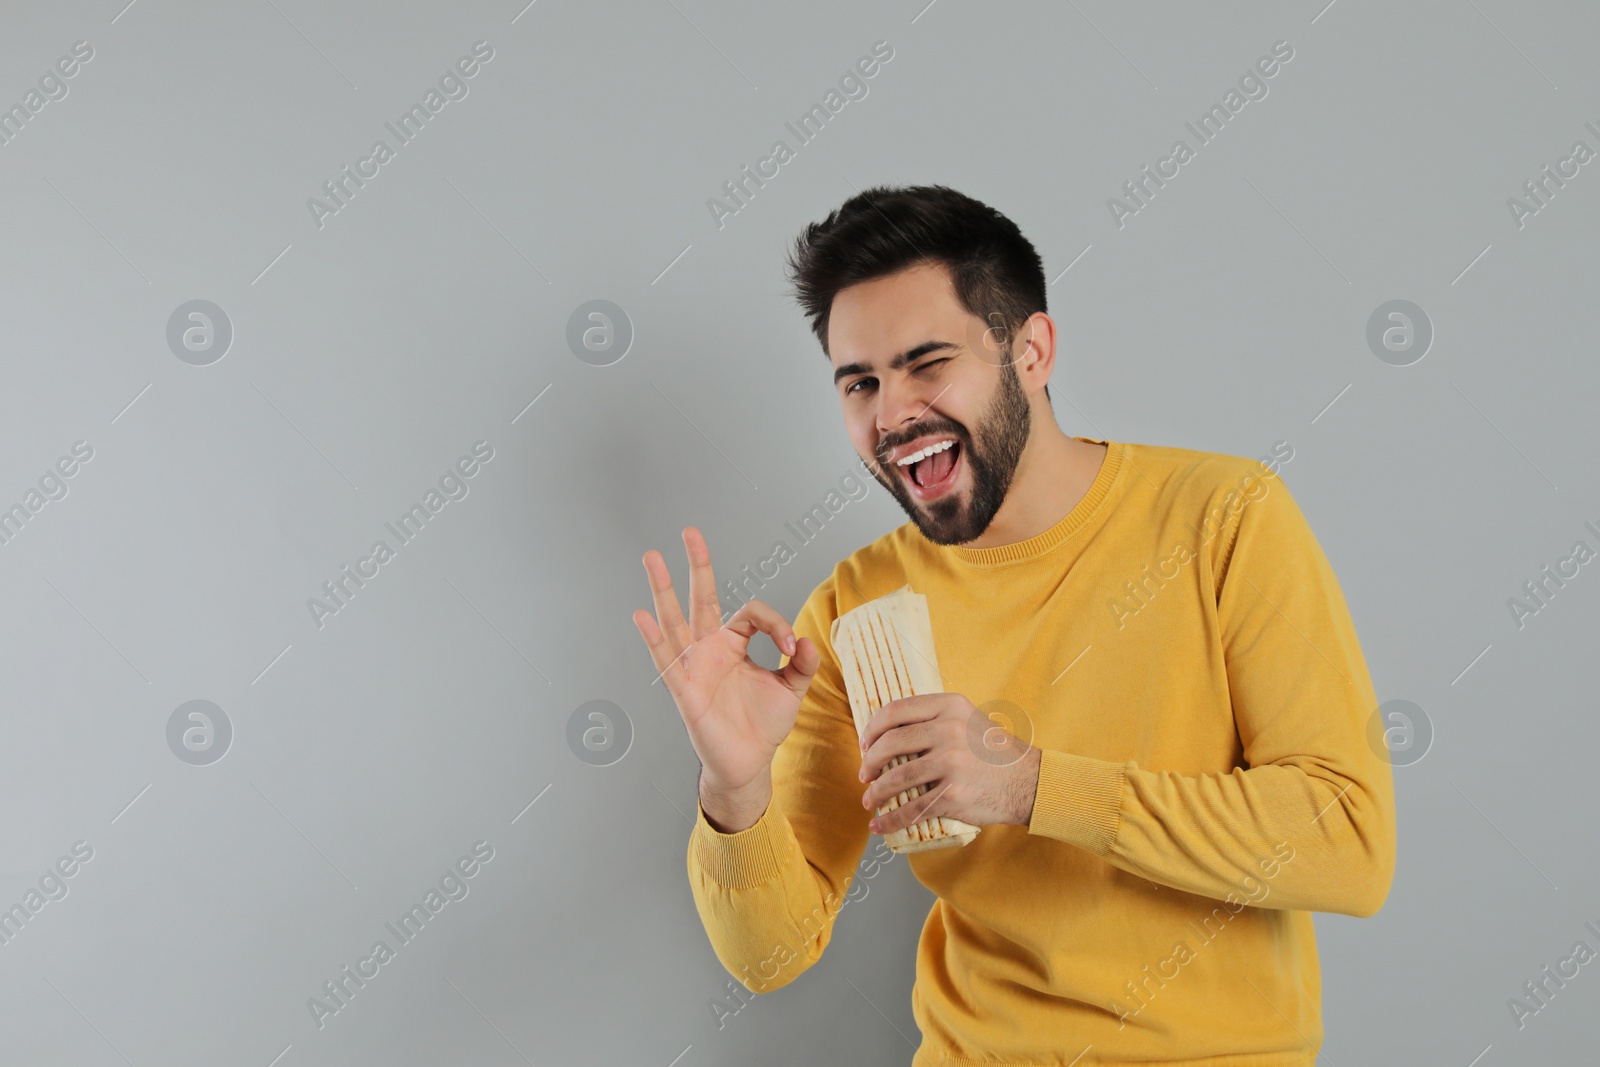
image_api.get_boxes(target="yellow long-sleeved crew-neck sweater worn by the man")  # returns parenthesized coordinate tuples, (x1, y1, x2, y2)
(688, 438, 1395, 1067)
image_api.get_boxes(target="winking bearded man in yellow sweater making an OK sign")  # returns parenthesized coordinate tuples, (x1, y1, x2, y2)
(634, 186, 1395, 1067)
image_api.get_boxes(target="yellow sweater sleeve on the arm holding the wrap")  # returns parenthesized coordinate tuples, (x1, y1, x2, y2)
(1029, 467, 1395, 917)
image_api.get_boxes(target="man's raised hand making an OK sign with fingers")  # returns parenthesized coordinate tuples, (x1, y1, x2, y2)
(634, 526, 821, 833)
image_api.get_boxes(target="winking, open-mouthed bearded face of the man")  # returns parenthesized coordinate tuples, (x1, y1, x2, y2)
(827, 257, 1030, 544)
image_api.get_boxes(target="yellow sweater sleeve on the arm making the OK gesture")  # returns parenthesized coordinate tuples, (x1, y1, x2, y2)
(688, 577, 872, 993)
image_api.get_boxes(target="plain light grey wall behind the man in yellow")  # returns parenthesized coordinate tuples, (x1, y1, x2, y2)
(0, 0, 1600, 1067)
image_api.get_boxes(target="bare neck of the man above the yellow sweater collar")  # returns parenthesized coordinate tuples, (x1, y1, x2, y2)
(965, 405, 1106, 549)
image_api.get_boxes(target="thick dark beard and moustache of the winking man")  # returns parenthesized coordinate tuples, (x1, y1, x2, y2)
(872, 363, 1032, 545)
